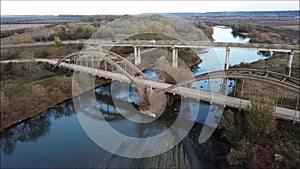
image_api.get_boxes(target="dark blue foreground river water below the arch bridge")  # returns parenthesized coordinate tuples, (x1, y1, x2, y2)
(1, 85, 226, 168)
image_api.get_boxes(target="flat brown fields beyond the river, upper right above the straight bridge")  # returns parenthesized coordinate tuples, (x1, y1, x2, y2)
(201, 16, 299, 44)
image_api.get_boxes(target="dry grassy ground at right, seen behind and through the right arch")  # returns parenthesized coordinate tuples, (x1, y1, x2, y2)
(231, 52, 300, 110)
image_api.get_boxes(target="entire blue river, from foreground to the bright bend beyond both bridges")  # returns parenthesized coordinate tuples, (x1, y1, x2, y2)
(1, 26, 264, 168)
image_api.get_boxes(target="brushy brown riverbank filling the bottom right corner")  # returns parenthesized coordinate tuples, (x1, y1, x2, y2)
(219, 107, 300, 168)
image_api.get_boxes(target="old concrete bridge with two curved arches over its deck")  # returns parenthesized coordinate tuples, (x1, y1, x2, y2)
(50, 43, 300, 122)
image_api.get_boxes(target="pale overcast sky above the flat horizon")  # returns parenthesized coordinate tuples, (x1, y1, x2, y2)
(1, 0, 299, 15)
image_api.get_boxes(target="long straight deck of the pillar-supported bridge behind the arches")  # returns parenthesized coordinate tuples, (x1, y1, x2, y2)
(0, 39, 300, 53)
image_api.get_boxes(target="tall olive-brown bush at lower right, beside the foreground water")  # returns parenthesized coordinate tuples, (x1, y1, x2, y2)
(219, 99, 282, 168)
